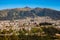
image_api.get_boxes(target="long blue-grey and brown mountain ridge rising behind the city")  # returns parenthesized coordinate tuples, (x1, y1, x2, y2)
(0, 7, 60, 20)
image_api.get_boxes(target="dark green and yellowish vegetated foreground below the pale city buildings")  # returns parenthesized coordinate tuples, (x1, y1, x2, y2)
(0, 26, 60, 40)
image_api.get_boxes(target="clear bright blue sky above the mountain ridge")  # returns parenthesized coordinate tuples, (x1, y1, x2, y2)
(0, 0, 60, 11)
